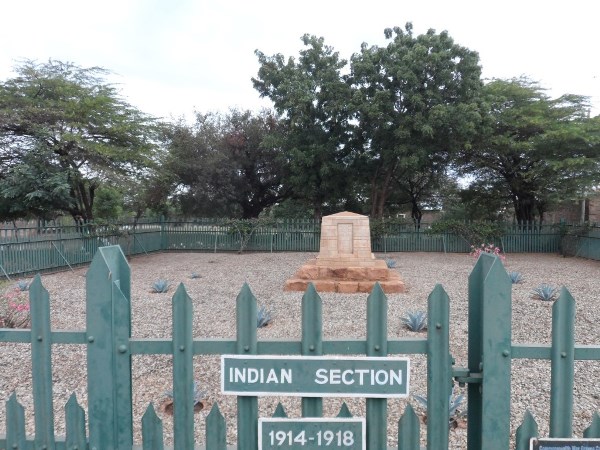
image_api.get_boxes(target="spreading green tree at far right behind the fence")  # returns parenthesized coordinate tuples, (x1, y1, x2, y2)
(462, 78, 600, 223)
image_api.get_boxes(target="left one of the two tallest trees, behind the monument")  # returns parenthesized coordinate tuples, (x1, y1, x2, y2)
(252, 34, 353, 218)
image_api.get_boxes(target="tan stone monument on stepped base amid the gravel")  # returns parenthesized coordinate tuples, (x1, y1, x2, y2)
(284, 212, 404, 293)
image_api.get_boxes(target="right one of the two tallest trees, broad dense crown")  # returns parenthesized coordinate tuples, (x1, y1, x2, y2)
(348, 23, 481, 221)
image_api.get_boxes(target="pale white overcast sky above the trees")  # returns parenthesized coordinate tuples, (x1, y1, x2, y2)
(0, 0, 600, 119)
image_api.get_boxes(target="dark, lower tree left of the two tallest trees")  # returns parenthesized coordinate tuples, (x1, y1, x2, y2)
(166, 110, 286, 219)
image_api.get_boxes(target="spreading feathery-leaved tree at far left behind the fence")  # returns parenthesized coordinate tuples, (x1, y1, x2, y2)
(0, 61, 156, 221)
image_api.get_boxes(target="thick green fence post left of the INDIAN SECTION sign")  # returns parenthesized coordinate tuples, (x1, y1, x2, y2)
(86, 246, 133, 450)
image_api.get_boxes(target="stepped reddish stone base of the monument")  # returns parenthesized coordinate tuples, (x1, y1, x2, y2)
(284, 258, 405, 294)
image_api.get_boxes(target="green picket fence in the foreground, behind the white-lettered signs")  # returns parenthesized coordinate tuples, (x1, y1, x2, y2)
(0, 246, 600, 450)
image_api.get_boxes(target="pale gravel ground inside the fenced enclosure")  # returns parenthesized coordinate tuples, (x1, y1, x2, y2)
(0, 253, 600, 449)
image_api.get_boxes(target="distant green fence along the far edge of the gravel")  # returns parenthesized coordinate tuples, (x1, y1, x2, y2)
(0, 219, 600, 277)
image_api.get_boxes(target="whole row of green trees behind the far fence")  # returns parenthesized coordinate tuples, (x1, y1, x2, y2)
(0, 24, 600, 227)
